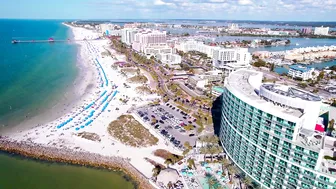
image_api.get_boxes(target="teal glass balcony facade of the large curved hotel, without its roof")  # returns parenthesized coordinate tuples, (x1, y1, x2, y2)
(220, 89, 336, 189)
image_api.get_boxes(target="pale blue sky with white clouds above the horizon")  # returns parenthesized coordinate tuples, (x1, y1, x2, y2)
(0, 0, 336, 21)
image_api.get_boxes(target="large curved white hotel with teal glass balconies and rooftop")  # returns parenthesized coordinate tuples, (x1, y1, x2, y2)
(220, 69, 336, 189)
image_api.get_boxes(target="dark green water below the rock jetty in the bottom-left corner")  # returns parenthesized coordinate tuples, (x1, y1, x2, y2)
(0, 153, 135, 189)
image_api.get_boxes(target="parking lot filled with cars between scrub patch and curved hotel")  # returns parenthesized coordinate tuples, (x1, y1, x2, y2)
(136, 103, 198, 150)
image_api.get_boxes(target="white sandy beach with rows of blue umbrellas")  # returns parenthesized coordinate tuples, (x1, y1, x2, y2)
(4, 27, 180, 178)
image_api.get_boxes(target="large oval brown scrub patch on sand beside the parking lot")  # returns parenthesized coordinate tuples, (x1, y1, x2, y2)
(107, 115, 159, 147)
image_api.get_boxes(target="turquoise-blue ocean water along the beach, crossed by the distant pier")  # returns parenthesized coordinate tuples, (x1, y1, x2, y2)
(0, 20, 77, 128)
